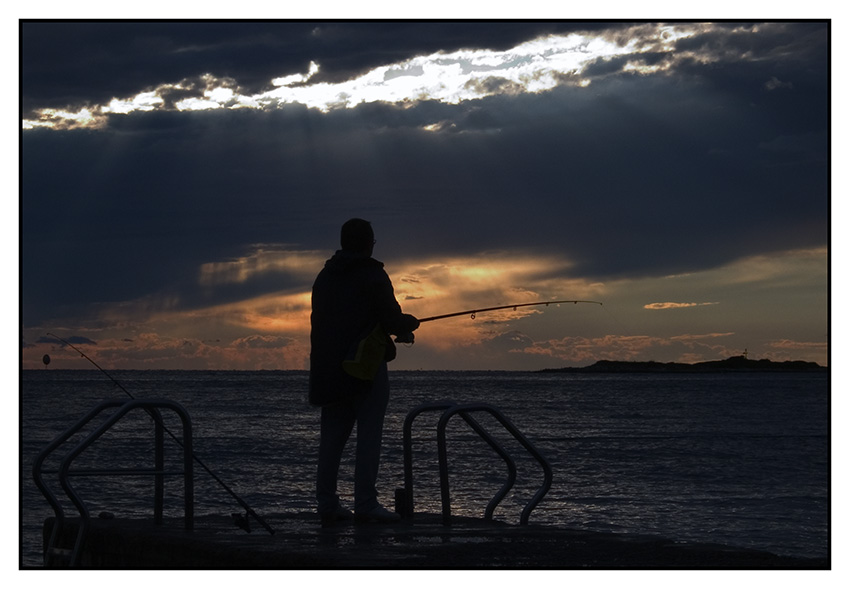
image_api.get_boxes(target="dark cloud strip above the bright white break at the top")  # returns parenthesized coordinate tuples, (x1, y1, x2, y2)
(21, 21, 622, 117)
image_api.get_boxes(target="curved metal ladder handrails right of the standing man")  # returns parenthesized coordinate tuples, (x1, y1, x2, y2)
(396, 401, 552, 526)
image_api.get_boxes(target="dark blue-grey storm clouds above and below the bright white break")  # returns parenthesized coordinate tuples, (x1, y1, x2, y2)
(22, 23, 828, 330)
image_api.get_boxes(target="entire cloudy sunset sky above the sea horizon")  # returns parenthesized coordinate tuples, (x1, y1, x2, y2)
(19, 19, 831, 370)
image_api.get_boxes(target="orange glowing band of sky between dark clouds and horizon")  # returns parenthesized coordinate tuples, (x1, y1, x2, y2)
(23, 243, 827, 369)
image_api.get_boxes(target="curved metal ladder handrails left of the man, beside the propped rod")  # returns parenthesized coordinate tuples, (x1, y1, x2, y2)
(32, 399, 195, 567)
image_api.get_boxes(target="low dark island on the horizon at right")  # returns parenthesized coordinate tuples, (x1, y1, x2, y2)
(540, 356, 829, 374)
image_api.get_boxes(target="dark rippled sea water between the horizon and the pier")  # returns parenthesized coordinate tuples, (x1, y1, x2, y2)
(20, 368, 830, 566)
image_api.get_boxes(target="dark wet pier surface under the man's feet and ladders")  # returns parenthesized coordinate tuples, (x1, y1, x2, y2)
(44, 514, 830, 569)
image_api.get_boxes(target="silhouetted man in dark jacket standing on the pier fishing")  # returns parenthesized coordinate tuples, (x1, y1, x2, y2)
(309, 219, 419, 526)
